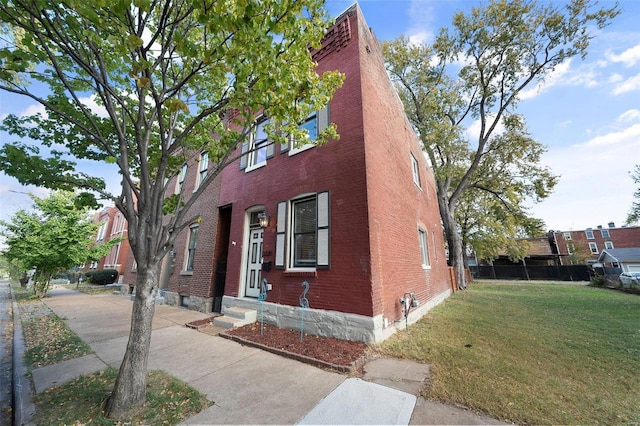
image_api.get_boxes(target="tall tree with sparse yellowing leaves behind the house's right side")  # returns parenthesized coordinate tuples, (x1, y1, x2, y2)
(383, 0, 618, 289)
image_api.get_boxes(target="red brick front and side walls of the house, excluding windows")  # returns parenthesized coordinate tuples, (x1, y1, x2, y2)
(220, 4, 449, 321)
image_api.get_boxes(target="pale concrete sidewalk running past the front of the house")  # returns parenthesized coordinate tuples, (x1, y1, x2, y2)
(15, 288, 502, 425)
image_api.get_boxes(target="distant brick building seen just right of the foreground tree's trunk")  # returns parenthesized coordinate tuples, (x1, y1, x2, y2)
(83, 206, 133, 282)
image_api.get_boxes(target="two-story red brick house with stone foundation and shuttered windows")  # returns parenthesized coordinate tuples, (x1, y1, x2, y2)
(126, 4, 452, 342)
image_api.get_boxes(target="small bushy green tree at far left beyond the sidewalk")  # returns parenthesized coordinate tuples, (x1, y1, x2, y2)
(0, 191, 114, 298)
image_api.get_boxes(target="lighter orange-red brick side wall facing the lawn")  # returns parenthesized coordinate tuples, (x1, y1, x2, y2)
(358, 11, 450, 320)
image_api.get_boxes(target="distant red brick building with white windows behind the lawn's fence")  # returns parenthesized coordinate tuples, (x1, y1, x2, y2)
(554, 222, 640, 265)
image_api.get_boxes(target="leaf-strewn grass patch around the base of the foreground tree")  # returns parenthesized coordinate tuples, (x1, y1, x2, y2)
(34, 369, 211, 425)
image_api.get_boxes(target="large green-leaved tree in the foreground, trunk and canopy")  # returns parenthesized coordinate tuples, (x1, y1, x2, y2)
(0, 0, 342, 418)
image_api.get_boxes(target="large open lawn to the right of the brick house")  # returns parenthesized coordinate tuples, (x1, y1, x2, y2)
(379, 283, 640, 424)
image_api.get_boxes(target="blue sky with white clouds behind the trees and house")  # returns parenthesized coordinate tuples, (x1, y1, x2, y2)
(0, 0, 640, 230)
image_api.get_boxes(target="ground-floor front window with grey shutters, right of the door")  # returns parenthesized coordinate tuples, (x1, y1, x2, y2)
(275, 192, 330, 270)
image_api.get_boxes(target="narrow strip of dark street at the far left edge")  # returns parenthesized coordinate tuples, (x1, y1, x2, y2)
(0, 280, 13, 425)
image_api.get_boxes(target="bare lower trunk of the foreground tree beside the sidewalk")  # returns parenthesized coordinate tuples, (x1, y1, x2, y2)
(104, 267, 158, 420)
